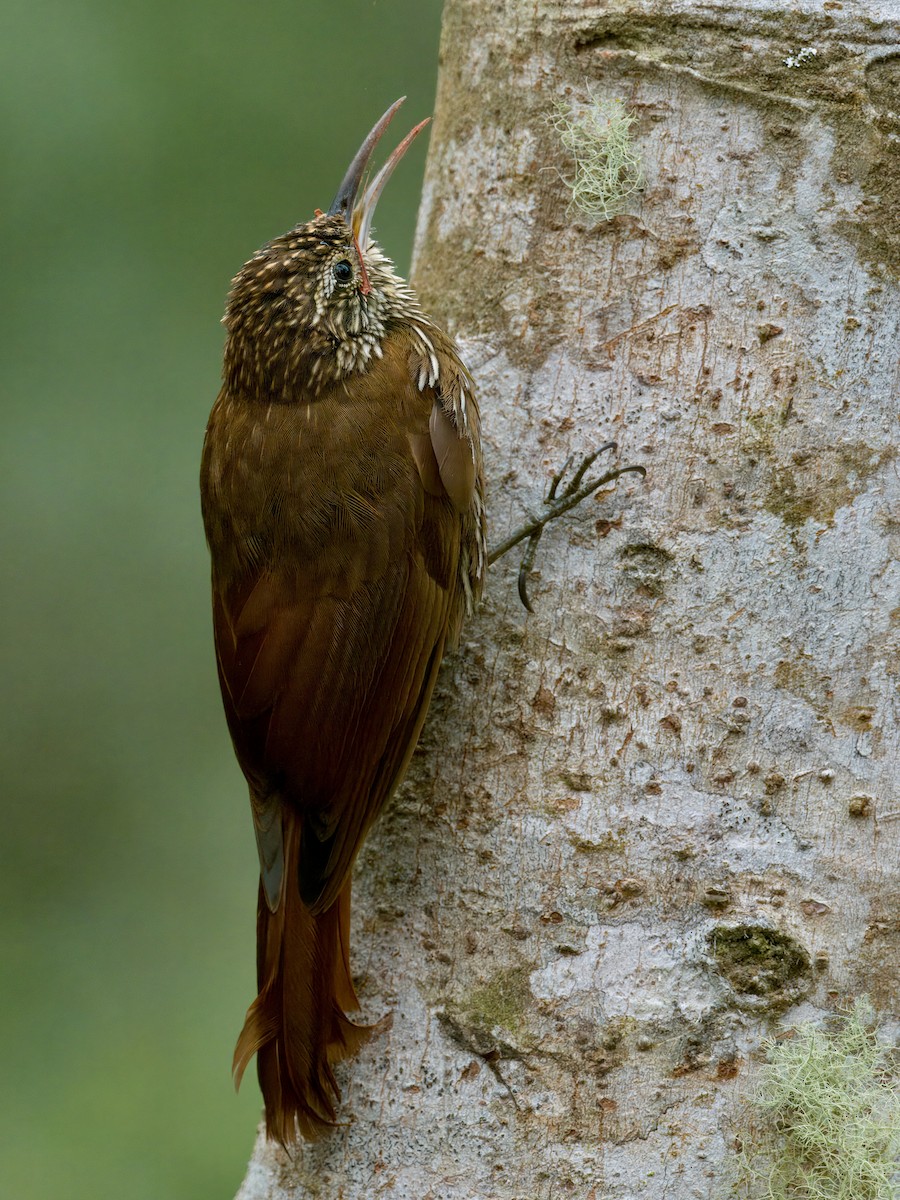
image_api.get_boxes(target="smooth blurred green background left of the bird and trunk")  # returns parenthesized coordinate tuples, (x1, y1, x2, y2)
(0, 0, 440, 1200)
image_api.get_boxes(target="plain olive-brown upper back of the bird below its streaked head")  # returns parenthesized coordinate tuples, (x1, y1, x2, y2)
(202, 340, 432, 588)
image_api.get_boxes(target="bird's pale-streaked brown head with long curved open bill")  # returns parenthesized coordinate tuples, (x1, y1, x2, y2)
(224, 100, 428, 400)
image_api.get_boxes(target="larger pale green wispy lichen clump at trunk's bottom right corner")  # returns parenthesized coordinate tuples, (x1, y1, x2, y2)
(743, 1001, 900, 1200)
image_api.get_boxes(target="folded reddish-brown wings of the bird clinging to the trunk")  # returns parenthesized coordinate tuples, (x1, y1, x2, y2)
(207, 333, 474, 913)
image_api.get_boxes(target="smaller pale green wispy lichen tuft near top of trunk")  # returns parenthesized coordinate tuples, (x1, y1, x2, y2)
(550, 92, 643, 221)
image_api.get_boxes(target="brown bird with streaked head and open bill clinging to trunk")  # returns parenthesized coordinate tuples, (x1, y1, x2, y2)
(200, 101, 486, 1146)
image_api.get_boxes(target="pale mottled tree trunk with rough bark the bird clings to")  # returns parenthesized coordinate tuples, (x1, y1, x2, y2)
(240, 0, 900, 1200)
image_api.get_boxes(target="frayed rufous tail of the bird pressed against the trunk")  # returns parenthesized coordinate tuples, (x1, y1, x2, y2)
(232, 817, 371, 1147)
